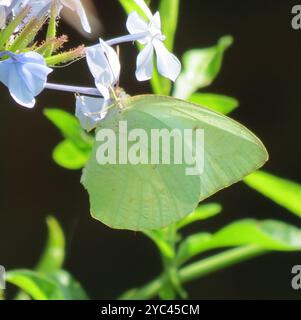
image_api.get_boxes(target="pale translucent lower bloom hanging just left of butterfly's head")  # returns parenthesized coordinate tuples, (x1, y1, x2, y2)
(75, 96, 110, 131)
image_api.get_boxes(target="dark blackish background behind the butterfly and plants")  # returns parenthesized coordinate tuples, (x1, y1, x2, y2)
(0, 0, 301, 299)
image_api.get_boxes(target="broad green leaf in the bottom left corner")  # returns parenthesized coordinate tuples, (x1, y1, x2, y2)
(6, 270, 87, 300)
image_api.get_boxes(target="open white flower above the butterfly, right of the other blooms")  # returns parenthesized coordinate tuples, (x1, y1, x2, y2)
(127, 0, 181, 81)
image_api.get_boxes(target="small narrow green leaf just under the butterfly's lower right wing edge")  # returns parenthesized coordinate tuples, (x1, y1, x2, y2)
(177, 203, 223, 229)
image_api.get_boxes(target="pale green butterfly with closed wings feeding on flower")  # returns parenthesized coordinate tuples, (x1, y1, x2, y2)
(82, 95, 268, 231)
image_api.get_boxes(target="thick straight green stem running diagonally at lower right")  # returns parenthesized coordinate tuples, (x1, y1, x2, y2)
(120, 245, 268, 300)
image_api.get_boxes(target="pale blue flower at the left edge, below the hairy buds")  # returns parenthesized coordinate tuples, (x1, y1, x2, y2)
(0, 52, 52, 108)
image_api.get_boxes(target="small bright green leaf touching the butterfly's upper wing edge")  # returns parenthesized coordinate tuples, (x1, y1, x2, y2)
(189, 93, 239, 114)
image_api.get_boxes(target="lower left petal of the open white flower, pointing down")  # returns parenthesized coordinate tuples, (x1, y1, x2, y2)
(136, 43, 154, 81)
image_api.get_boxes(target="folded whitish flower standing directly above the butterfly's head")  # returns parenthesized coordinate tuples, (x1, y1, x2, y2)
(86, 39, 120, 100)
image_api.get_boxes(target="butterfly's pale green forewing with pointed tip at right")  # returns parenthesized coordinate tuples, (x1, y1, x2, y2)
(130, 95, 268, 200)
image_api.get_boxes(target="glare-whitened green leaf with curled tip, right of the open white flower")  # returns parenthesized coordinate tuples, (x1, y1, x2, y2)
(173, 36, 233, 99)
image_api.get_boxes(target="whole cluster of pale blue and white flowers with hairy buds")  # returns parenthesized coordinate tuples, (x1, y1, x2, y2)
(0, 0, 181, 131)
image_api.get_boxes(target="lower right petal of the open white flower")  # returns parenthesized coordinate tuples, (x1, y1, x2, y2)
(153, 39, 181, 81)
